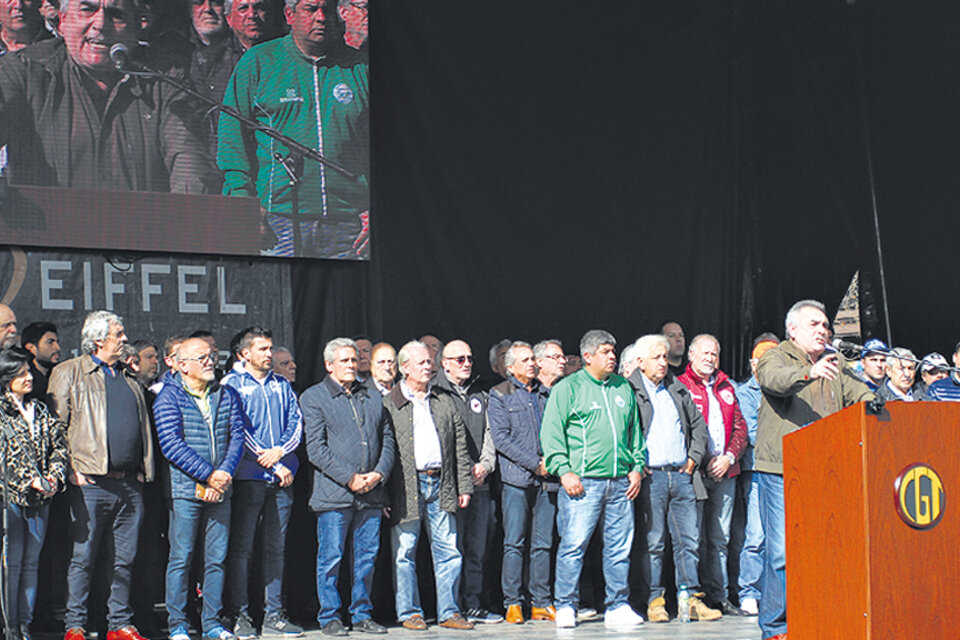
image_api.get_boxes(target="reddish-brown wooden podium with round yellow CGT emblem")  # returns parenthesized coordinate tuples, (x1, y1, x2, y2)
(783, 402, 960, 640)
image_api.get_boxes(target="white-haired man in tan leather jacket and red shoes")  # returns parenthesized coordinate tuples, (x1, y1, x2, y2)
(47, 312, 154, 640)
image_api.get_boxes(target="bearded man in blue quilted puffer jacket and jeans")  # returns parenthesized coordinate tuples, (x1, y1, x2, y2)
(153, 338, 246, 640)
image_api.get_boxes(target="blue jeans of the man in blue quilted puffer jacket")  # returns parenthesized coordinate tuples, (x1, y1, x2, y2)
(166, 498, 230, 631)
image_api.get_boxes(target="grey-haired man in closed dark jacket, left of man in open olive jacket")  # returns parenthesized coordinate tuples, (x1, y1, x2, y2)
(300, 338, 396, 636)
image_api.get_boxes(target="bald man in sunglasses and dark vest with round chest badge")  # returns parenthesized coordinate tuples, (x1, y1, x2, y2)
(434, 340, 503, 623)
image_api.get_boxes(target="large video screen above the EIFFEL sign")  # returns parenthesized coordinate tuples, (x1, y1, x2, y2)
(0, 0, 370, 260)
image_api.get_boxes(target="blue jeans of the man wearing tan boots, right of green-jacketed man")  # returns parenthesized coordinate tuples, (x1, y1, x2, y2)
(640, 471, 700, 603)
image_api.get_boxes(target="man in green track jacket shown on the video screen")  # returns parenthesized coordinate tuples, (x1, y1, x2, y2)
(217, 0, 370, 259)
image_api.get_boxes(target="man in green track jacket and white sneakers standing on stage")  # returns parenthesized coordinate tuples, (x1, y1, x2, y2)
(540, 329, 646, 628)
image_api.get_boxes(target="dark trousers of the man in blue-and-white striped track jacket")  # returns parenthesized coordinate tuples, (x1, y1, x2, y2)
(227, 480, 293, 615)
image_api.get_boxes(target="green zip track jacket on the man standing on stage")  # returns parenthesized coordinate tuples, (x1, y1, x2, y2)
(540, 369, 647, 478)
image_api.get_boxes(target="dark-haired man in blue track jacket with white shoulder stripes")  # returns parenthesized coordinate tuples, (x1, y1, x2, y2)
(223, 327, 303, 640)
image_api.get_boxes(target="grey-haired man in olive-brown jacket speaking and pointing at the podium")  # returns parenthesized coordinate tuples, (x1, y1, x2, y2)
(754, 300, 874, 639)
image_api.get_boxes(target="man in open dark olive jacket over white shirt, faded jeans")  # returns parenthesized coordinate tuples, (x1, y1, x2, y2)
(383, 341, 473, 629)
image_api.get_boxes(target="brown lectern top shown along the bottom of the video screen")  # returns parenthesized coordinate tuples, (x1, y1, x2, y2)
(0, 186, 260, 256)
